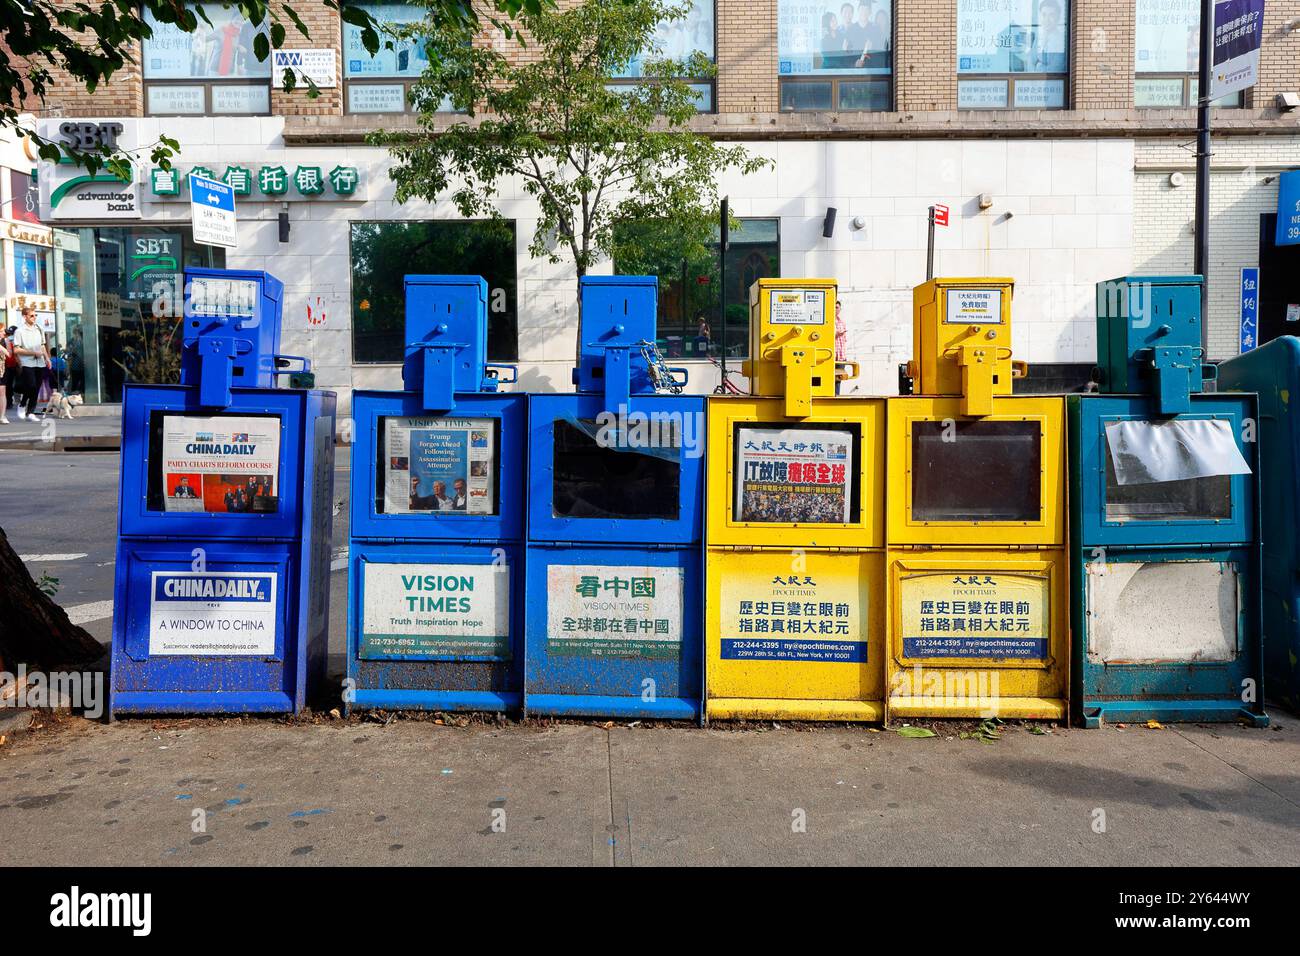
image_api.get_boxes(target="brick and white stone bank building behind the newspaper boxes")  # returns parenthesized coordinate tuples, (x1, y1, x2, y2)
(25, 0, 1300, 405)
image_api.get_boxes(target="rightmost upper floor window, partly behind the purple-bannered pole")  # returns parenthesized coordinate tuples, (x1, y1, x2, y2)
(1134, 0, 1242, 109)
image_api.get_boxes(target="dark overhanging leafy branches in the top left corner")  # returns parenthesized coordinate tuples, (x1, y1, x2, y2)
(0, 0, 554, 178)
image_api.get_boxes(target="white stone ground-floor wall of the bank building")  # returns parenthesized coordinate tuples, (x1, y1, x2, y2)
(129, 117, 1134, 402)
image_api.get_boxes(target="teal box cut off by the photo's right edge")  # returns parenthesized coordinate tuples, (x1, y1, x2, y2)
(1218, 336, 1300, 713)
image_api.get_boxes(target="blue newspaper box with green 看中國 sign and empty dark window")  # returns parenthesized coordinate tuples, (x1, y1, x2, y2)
(524, 276, 705, 719)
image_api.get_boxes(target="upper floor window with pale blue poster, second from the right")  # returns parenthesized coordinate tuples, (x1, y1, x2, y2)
(957, 0, 1070, 109)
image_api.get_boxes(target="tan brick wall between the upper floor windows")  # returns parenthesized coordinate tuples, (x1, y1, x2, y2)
(15, 0, 1300, 138)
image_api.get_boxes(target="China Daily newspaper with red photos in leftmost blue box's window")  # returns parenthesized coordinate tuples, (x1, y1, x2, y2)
(161, 415, 280, 514)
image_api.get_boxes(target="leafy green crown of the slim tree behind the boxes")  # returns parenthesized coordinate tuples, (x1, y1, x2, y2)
(371, 0, 767, 317)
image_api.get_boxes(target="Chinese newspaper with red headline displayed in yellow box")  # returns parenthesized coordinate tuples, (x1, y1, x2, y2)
(736, 428, 853, 524)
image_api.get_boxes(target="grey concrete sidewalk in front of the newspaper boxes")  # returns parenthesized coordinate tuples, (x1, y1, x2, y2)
(0, 714, 1300, 866)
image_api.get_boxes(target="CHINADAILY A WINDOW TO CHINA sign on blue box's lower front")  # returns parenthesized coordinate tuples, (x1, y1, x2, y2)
(150, 571, 280, 657)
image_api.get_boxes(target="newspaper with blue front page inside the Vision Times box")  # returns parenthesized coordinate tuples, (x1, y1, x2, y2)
(384, 418, 497, 515)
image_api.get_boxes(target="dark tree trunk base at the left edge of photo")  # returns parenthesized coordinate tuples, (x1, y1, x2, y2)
(0, 528, 104, 671)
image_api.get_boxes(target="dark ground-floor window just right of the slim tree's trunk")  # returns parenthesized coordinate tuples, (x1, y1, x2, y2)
(614, 219, 781, 359)
